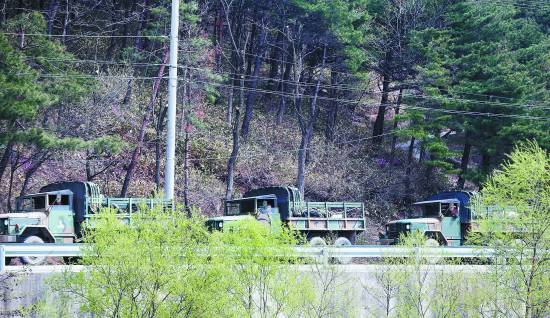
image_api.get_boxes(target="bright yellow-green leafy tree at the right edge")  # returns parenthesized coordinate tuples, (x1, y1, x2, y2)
(470, 142, 550, 317)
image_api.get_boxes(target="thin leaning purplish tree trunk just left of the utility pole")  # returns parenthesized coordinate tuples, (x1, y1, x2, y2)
(120, 44, 169, 197)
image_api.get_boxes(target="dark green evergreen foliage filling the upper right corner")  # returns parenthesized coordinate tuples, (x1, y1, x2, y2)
(411, 1, 550, 181)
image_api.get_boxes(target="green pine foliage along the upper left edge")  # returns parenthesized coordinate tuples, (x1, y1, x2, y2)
(0, 12, 98, 150)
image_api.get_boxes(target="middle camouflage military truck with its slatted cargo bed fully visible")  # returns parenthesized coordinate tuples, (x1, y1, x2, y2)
(207, 186, 366, 246)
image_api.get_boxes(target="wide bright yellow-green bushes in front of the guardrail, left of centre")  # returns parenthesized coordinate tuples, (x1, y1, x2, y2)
(45, 209, 313, 317)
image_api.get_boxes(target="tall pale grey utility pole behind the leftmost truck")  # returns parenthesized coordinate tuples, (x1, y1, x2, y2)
(164, 0, 180, 200)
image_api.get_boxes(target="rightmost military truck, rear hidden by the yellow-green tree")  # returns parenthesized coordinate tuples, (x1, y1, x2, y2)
(379, 191, 474, 246)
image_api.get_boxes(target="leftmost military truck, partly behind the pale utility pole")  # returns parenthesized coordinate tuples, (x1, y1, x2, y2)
(0, 182, 172, 264)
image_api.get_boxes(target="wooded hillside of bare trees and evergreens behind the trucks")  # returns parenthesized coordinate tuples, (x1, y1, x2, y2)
(0, 0, 550, 238)
